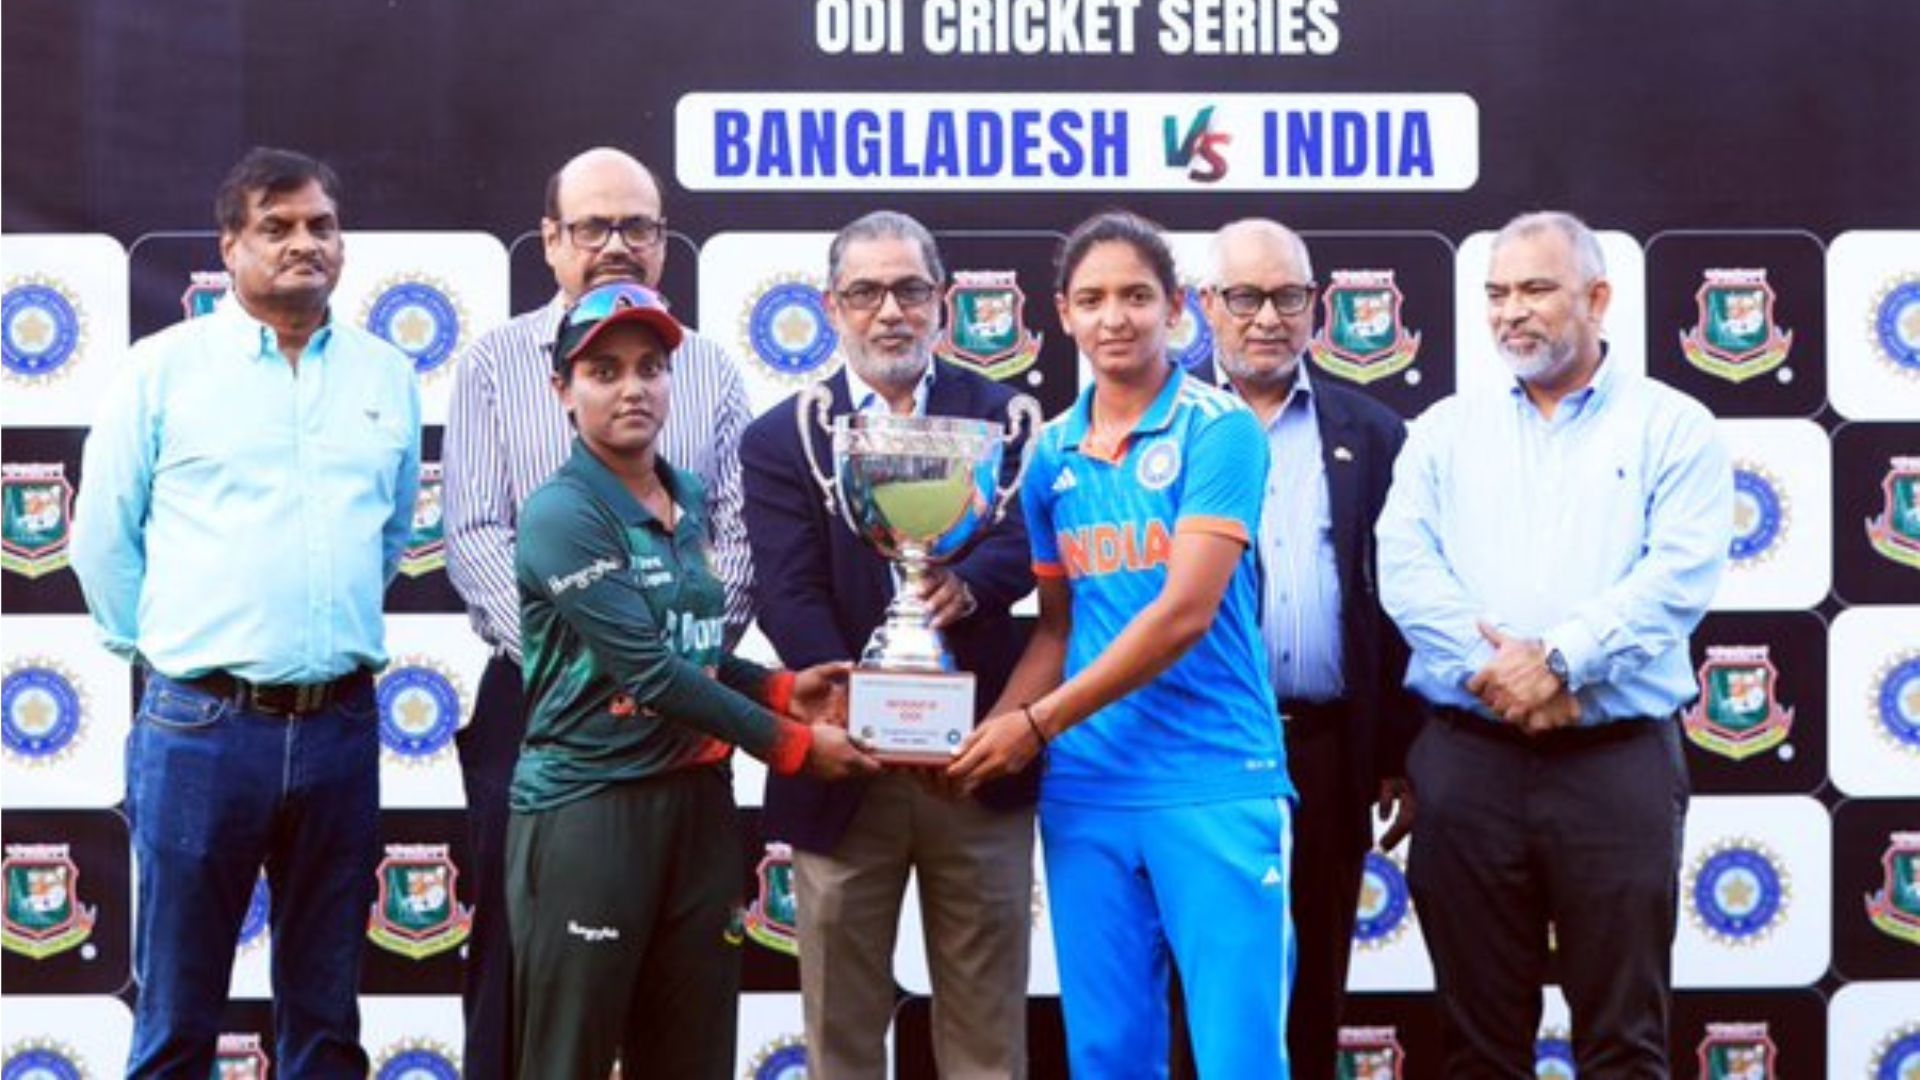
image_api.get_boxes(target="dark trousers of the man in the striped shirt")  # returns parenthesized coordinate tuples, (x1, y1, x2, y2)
(457, 655, 526, 1080)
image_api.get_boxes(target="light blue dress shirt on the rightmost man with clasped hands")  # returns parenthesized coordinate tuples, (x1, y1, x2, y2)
(1375, 361, 1734, 724)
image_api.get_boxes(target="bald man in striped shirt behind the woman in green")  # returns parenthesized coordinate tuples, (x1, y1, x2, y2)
(442, 148, 753, 1080)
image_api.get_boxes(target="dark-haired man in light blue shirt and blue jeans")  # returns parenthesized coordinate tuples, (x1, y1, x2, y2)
(73, 150, 420, 1080)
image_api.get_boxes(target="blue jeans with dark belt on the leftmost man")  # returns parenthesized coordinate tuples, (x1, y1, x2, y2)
(127, 673, 380, 1080)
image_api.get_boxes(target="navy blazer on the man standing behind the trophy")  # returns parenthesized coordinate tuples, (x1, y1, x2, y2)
(739, 361, 1039, 851)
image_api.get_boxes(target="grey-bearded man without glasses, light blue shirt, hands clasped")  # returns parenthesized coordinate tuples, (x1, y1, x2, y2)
(1377, 213, 1734, 1076)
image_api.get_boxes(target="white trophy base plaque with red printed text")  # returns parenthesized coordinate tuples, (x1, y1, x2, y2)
(847, 667, 973, 765)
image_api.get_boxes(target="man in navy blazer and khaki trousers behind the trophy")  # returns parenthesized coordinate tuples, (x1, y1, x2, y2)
(741, 211, 1039, 1080)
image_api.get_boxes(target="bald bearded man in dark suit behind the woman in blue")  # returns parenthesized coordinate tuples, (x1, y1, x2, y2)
(1202, 219, 1421, 1080)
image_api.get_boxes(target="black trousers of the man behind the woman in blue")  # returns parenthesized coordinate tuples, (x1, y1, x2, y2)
(1286, 715, 1373, 1080)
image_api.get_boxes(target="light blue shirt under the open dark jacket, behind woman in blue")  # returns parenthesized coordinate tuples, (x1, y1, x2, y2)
(1236, 363, 1346, 701)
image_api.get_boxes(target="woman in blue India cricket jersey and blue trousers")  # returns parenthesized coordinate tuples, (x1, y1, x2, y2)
(948, 211, 1292, 1078)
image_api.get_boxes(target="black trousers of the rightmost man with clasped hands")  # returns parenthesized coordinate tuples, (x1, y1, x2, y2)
(1407, 711, 1690, 1080)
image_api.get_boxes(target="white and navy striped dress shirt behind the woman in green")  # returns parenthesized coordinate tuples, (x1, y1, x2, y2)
(442, 296, 753, 661)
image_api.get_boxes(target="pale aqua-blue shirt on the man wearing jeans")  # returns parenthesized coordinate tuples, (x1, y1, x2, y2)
(71, 296, 420, 682)
